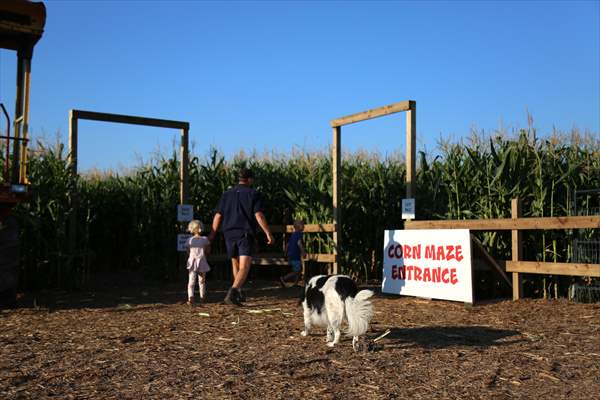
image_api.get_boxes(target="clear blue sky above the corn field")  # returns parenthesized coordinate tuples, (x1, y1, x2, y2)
(0, 0, 600, 169)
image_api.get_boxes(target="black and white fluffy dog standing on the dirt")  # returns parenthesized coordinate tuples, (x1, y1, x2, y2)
(300, 275, 373, 349)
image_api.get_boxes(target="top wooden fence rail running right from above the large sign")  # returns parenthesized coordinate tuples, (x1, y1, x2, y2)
(404, 216, 600, 231)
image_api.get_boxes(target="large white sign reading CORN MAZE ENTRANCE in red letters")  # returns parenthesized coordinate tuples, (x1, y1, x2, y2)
(381, 229, 473, 303)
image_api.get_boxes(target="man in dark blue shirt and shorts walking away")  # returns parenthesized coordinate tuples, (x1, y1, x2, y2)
(209, 168, 274, 306)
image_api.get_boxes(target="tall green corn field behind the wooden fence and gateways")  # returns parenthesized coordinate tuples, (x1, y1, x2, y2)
(2, 129, 600, 296)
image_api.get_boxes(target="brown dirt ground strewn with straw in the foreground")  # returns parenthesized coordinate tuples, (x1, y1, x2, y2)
(0, 281, 600, 399)
